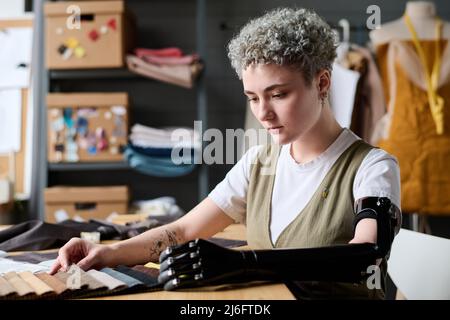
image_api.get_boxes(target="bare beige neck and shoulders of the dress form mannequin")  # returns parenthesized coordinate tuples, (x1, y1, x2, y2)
(369, 1, 450, 45)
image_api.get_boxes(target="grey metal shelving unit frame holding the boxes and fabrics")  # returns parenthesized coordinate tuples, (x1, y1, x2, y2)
(29, 0, 209, 219)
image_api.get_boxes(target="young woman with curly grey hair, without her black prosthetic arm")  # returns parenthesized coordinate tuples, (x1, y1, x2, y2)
(51, 8, 400, 300)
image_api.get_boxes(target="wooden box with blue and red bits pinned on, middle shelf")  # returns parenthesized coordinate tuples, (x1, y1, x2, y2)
(47, 93, 128, 163)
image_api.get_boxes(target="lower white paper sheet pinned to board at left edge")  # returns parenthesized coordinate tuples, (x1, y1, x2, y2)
(0, 89, 22, 153)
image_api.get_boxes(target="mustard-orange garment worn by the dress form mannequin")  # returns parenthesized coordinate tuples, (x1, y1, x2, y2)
(373, 18, 450, 215)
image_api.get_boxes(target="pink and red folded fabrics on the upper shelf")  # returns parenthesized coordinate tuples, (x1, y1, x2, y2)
(127, 47, 203, 88)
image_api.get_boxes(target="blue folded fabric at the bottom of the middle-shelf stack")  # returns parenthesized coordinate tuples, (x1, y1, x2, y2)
(124, 147, 195, 177)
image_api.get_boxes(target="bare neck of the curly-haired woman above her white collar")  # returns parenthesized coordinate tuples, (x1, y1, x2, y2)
(290, 106, 343, 163)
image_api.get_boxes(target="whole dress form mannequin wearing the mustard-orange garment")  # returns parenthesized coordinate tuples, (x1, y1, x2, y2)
(369, 1, 450, 225)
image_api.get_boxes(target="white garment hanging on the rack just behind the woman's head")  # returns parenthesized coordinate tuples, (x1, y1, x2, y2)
(330, 63, 360, 128)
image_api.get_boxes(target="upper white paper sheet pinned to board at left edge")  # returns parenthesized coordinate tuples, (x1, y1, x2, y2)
(0, 28, 33, 89)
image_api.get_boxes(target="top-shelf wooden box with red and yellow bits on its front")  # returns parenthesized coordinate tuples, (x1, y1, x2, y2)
(44, 1, 135, 69)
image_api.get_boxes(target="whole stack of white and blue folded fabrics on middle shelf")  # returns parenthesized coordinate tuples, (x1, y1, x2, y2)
(124, 124, 201, 177)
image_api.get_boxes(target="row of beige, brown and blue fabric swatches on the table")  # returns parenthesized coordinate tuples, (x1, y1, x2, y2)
(0, 258, 162, 300)
